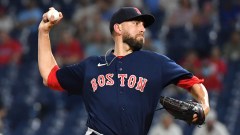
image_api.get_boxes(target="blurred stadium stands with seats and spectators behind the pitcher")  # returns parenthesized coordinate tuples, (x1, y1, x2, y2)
(0, 0, 240, 135)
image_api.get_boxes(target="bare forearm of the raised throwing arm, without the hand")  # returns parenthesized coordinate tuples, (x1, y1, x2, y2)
(38, 30, 57, 85)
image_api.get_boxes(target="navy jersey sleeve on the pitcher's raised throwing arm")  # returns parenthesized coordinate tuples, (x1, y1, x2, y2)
(56, 63, 84, 94)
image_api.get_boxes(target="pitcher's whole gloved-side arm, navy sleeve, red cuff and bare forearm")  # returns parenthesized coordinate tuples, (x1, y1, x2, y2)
(160, 55, 210, 116)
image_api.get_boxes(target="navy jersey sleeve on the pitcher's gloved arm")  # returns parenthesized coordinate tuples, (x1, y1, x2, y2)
(161, 56, 193, 87)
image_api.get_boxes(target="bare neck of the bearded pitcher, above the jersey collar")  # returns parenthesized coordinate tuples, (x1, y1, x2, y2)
(113, 37, 133, 56)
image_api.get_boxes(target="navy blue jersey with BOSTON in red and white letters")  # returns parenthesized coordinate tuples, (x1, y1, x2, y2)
(57, 51, 192, 135)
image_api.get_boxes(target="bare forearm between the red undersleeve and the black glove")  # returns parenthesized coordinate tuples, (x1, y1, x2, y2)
(191, 84, 210, 115)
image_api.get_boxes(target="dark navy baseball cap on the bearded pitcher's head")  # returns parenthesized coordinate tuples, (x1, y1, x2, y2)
(109, 7, 155, 33)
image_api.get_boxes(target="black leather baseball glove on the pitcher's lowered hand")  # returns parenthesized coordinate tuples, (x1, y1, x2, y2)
(160, 96, 205, 125)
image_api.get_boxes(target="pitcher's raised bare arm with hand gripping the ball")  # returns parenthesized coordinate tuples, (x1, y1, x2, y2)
(38, 8, 63, 86)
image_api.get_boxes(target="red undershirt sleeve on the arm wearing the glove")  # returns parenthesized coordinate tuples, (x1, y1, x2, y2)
(177, 76, 204, 91)
